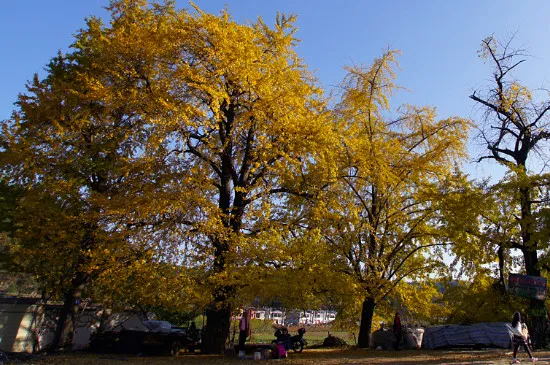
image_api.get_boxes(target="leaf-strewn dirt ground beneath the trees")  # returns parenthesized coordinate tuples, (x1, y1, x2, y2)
(5, 349, 550, 365)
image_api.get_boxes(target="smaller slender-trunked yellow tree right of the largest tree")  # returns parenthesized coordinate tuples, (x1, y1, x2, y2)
(323, 51, 469, 347)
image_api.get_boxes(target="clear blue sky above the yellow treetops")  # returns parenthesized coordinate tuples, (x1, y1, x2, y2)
(0, 0, 550, 176)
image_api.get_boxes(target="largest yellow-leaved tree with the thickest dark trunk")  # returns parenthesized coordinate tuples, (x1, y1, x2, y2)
(132, 1, 332, 353)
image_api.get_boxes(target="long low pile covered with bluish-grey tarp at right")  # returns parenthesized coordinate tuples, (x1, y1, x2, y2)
(422, 322, 512, 349)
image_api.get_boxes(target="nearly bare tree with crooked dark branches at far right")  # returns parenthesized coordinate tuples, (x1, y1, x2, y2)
(470, 36, 550, 346)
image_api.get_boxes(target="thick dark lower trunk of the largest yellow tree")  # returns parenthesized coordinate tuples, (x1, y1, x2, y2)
(202, 302, 231, 354)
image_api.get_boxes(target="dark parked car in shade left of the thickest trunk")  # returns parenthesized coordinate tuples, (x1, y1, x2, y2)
(90, 321, 200, 356)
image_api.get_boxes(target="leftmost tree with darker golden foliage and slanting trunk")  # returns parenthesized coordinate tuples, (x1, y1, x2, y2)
(0, 0, 198, 347)
